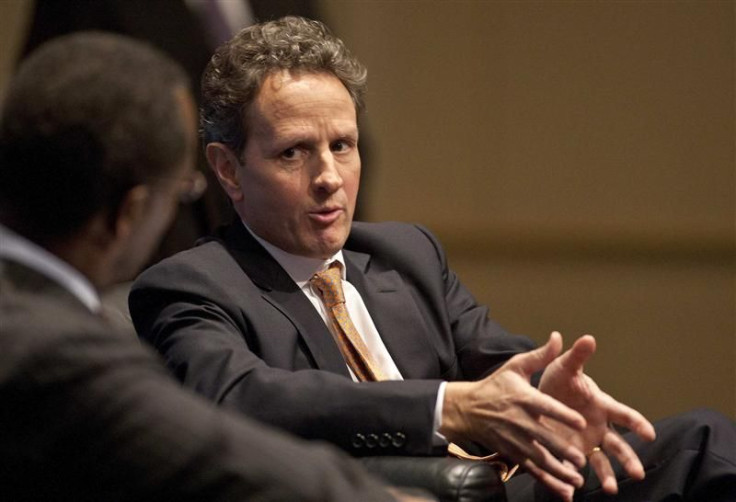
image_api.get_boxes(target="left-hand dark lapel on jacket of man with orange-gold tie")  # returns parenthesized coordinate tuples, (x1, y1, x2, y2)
(210, 221, 350, 378)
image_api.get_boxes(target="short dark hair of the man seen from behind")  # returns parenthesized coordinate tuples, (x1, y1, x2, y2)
(0, 32, 188, 242)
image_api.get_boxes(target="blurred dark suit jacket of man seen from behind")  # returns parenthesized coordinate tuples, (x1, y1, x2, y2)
(0, 258, 393, 502)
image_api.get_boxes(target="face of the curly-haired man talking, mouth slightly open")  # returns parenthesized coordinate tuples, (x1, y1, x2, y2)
(231, 71, 360, 258)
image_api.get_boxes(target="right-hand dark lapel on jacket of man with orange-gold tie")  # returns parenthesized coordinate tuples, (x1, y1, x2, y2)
(343, 250, 440, 379)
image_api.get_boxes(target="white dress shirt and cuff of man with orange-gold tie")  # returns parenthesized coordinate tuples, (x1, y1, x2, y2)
(243, 223, 447, 445)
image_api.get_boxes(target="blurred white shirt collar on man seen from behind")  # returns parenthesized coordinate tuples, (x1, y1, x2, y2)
(0, 225, 102, 312)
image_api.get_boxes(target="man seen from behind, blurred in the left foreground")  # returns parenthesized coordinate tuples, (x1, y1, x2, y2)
(0, 33, 408, 502)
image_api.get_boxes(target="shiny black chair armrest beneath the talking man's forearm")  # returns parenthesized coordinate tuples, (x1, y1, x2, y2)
(360, 457, 506, 502)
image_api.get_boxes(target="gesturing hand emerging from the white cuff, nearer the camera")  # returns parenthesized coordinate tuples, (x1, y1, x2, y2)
(440, 333, 587, 500)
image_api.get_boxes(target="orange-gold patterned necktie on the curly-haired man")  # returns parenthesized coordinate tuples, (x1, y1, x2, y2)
(309, 261, 386, 382)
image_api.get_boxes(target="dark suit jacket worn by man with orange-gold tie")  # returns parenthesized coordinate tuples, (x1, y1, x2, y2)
(130, 221, 533, 455)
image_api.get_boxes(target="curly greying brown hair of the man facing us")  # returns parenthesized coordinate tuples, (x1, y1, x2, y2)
(200, 16, 367, 155)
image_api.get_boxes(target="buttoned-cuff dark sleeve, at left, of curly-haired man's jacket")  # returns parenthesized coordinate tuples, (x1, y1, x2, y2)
(129, 250, 440, 455)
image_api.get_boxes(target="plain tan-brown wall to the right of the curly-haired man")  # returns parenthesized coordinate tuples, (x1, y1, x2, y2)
(320, 0, 736, 418)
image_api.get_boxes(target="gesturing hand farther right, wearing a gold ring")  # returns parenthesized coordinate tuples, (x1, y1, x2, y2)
(539, 332, 655, 494)
